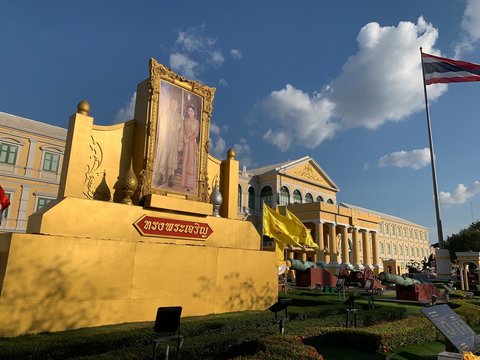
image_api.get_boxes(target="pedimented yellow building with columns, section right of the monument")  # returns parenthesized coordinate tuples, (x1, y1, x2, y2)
(238, 156, 430, 274)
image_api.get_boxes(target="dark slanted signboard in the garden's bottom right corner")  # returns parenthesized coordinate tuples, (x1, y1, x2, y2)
(421, 304, 480, 353)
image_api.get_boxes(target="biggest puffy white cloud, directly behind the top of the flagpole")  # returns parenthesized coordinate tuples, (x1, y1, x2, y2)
(328, 17, 447, 129)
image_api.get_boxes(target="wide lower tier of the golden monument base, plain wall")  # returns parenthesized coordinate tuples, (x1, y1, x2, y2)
(0, 234, 277, 336)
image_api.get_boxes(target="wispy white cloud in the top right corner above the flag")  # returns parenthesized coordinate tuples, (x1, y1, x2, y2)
(455, 0, 480, 57)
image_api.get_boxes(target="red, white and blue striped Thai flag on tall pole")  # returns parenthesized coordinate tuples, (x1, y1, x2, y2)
(422, 52, 480, 85)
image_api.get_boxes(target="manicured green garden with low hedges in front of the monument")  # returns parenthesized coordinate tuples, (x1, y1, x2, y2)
(0, 290, 480, 360)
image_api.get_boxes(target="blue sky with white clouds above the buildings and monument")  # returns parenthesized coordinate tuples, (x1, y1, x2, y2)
(0, 0, 480, 243)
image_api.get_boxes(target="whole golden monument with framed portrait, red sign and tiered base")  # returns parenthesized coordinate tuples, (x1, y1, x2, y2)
(0, 59, 278, 337)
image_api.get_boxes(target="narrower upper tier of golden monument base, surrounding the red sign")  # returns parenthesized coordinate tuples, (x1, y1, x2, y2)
(27, 197, 260, 250)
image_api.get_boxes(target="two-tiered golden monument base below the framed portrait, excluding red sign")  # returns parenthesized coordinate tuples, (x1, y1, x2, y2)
(0, 197, 278, 337)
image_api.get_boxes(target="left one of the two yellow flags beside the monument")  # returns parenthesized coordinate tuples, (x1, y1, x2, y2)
(263, 204, 300, 246)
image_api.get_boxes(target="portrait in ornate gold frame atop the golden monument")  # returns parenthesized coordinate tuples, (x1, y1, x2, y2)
(144, 59, 215, 202)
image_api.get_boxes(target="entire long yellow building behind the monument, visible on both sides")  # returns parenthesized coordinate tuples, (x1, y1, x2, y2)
(0, 112, 430, 274)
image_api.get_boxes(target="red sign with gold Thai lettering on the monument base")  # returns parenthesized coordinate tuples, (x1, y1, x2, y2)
(133, 215, 213, 240)
